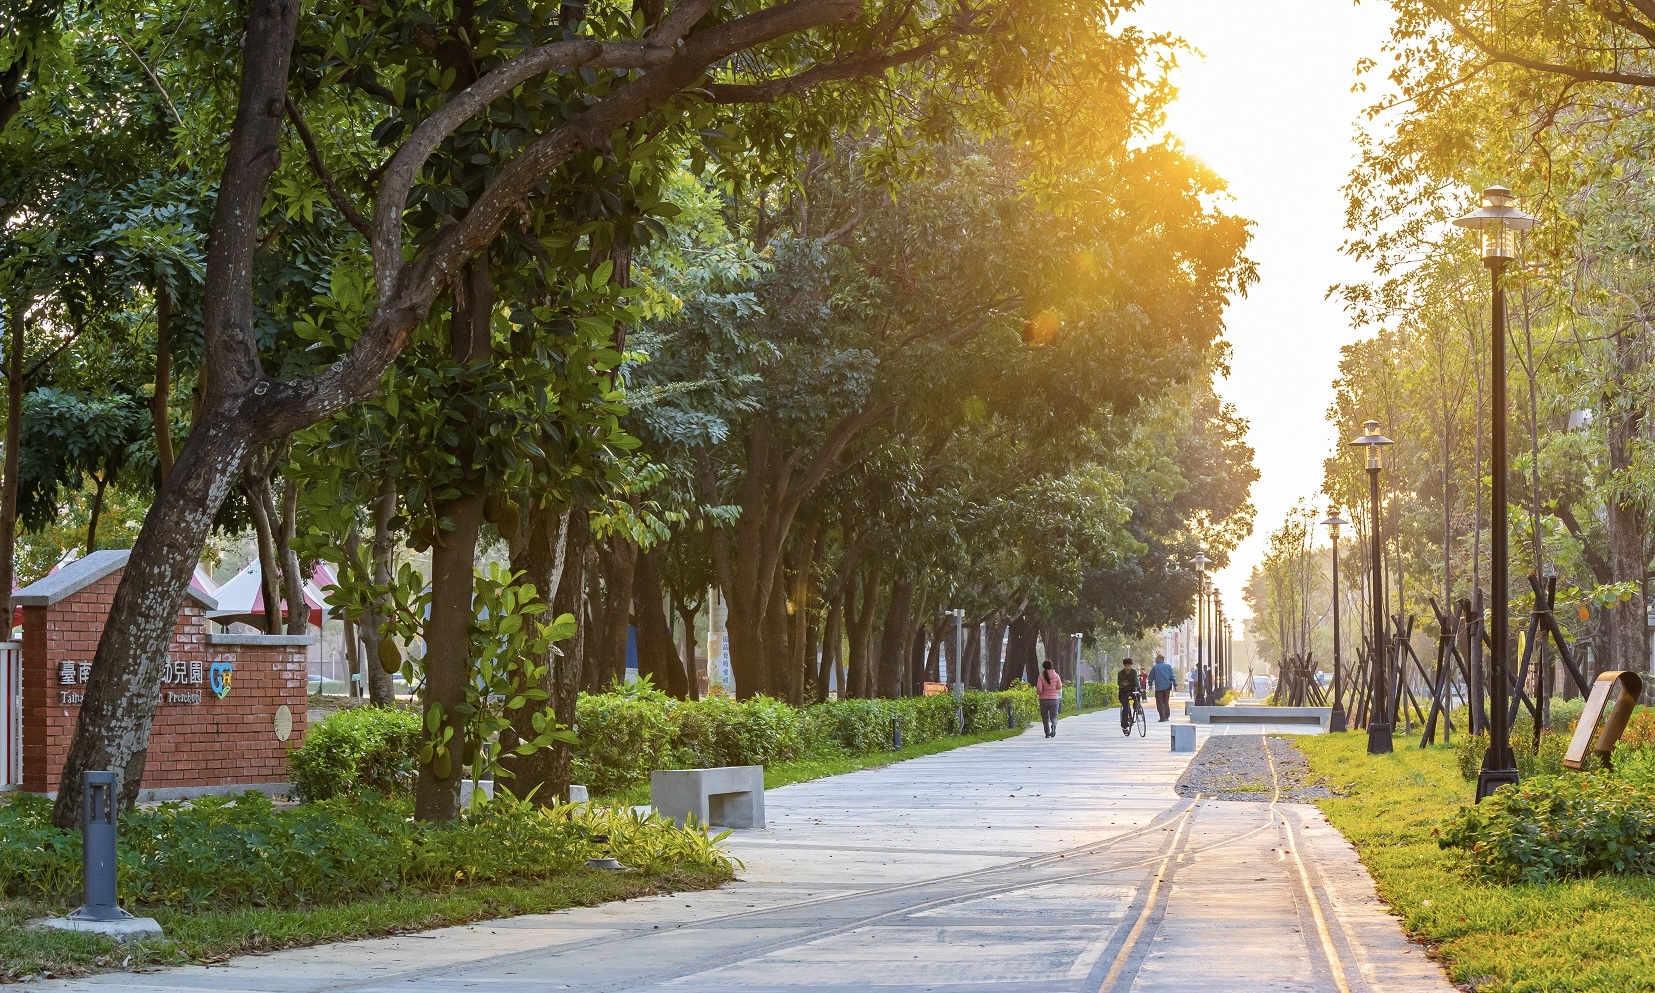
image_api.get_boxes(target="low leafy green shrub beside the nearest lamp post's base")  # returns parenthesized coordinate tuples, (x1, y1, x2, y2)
(1438, 773, 1655, 882)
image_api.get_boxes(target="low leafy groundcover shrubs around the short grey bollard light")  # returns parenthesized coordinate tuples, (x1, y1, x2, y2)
(0, 793, 732, 909)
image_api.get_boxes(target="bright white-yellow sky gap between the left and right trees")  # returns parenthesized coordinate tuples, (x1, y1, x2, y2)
(1129, 0, 1390, 621)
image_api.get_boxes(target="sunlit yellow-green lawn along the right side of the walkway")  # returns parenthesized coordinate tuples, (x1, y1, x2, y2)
(1293, 732, 1655, 993)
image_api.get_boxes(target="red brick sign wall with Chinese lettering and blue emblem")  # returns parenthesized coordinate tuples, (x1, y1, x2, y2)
(23, 569, 306, 793)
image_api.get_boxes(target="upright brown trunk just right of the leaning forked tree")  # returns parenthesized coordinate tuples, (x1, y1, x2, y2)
(414, 253, 495, 821)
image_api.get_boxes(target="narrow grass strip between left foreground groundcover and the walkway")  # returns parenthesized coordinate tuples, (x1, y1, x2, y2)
(0, 869, 727, 981)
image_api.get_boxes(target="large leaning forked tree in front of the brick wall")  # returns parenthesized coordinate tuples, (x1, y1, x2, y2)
(55, 0, 1191, 824)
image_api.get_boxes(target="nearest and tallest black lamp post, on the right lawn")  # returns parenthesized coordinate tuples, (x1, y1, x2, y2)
(1455, 187, 1534, 801)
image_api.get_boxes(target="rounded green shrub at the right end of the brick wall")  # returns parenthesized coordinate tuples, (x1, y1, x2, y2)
(290, 707, 420, 801)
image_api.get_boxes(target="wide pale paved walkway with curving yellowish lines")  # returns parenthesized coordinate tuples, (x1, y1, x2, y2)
(32, 712, 1451, 993)
